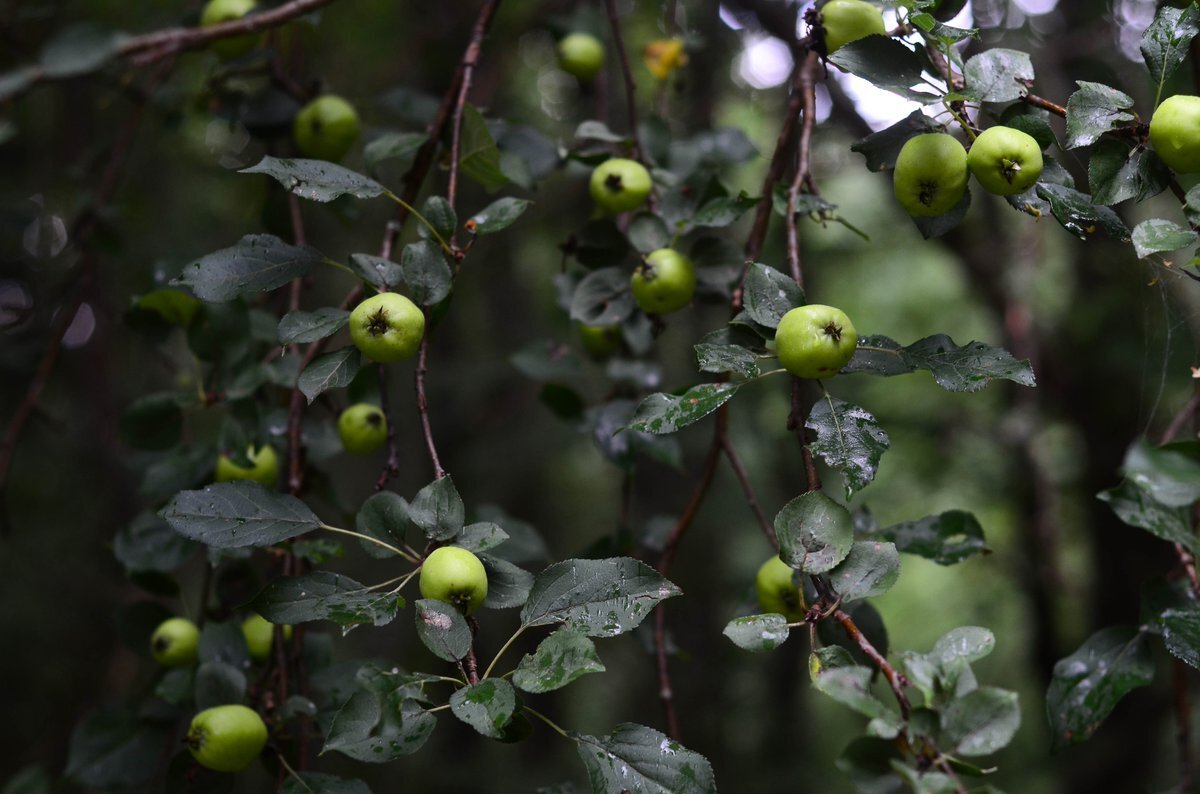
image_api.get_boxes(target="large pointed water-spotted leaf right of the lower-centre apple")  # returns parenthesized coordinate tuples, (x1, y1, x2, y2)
(521, 557, 680, 637)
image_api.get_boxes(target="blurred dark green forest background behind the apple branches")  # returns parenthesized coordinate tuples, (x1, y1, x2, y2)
(0, 0, 1200, 794)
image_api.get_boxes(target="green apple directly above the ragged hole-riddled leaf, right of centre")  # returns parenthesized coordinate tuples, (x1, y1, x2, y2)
(775, 303, 858, 378)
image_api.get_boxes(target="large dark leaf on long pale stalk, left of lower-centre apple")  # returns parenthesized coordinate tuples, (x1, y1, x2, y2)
(160, 480, 320, 548)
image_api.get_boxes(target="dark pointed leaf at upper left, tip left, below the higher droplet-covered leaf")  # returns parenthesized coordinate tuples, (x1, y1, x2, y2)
(170, 234, 325, 303)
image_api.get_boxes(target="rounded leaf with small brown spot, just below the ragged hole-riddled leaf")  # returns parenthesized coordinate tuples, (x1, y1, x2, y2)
(775, 491, 854, 573)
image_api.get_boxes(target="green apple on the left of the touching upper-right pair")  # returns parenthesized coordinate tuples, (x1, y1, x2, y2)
(892, 132, 970, 218)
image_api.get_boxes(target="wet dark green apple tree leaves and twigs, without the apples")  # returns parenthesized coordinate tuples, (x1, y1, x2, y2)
(7, 0, 1200, 794)
